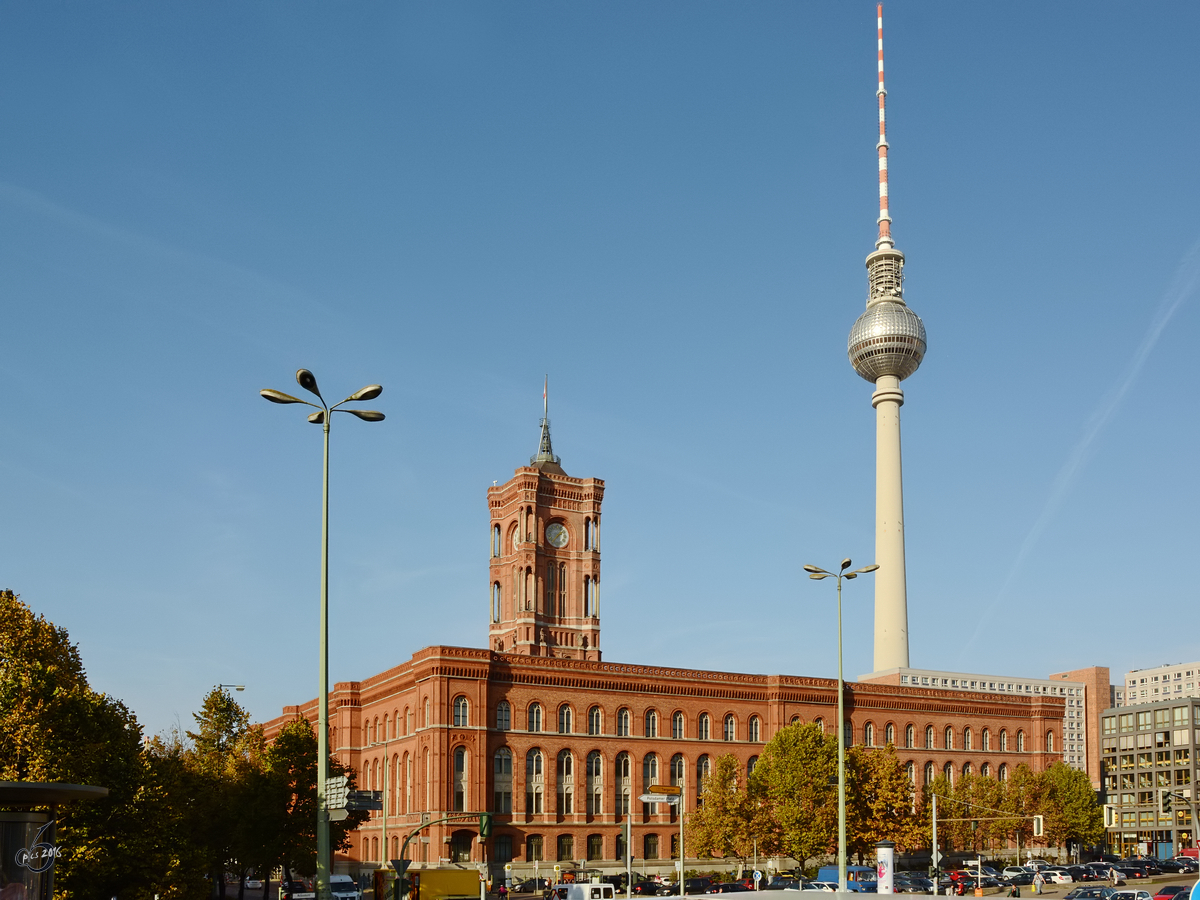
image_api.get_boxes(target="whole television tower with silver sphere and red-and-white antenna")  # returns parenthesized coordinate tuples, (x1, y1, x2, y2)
(846, 4, 925, 672)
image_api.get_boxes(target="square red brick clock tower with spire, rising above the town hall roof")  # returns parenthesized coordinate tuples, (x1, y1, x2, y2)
(487, 393, 604, 660)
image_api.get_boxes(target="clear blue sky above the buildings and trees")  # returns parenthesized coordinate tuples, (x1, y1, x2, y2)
(0, 0, 1200, 732)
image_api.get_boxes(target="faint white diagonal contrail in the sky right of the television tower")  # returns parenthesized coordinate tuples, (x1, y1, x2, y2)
(962, 241, 1200, 656)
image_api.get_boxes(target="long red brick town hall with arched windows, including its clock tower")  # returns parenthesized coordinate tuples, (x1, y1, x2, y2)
(266, 421, 1063, 871)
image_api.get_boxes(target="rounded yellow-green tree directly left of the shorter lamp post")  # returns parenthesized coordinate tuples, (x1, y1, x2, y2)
(750, 722, 838, 866)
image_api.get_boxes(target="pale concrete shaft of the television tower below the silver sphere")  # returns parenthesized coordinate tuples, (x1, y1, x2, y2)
(871, 376, 908, 672)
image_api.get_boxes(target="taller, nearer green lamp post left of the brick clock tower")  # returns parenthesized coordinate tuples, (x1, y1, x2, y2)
(259, 368, 384, 900)
